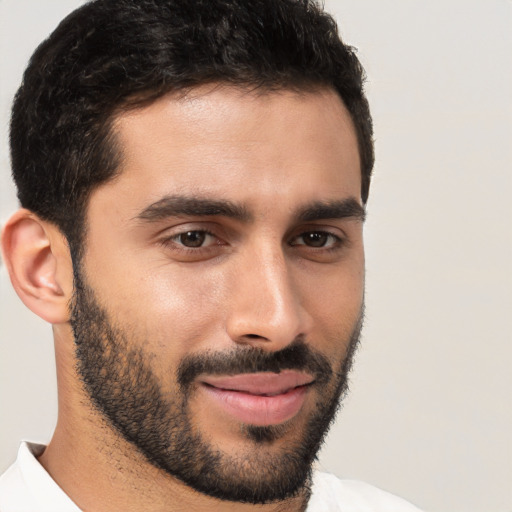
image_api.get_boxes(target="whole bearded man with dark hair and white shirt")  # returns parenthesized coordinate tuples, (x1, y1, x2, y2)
(0, 0, 422, 512)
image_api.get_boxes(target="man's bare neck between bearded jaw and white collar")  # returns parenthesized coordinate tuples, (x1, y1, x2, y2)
(39, 422, 309, 512)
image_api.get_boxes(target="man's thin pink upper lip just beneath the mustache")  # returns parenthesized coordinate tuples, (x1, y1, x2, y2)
(200, 370, 314, 396)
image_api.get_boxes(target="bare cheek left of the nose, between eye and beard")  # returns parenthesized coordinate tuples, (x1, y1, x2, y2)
(87, 259, 229, 358)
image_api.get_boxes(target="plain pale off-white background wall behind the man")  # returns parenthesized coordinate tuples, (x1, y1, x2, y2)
(0, 0, 512, 512)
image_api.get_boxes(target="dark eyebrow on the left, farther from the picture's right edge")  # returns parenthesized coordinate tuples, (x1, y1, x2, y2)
(136, 196, 253, 222)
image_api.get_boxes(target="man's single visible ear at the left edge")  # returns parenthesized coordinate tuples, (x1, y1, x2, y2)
(2, 209, 73, 324)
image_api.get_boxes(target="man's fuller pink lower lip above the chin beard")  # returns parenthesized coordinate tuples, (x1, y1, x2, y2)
(202, 385, 307, 426)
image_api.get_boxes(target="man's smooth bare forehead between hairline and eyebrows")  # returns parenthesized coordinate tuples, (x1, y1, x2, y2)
(91, 86, 360, 214)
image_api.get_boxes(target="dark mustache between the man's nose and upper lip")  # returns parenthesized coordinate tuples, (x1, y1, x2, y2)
(178, 337, 333, 390)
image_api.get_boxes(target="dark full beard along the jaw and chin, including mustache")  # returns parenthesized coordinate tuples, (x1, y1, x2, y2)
(71, 271, 363, 504)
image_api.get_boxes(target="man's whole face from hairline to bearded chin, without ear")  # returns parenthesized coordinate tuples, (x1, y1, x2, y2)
(72, 87, 364, 503)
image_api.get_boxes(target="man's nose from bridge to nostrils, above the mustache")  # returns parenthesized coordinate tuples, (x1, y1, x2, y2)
(227, 242, 312, 351)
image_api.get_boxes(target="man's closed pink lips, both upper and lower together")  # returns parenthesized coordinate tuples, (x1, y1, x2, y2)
(200, 370, 314, 426)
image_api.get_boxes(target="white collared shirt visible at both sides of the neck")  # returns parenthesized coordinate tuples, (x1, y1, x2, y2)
(0, 442, 419, 512)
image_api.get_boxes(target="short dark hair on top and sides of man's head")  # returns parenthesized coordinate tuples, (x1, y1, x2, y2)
(10, 0, 374, 255)
